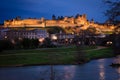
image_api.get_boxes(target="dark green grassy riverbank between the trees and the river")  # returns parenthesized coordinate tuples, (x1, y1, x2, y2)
(0, 47, 115, 67)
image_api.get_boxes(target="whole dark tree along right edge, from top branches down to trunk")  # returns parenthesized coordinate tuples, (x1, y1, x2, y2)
(104, 0, 120, 54)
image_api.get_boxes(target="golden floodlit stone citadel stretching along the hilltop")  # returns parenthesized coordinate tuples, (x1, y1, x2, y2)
(4, 14, 114, 31)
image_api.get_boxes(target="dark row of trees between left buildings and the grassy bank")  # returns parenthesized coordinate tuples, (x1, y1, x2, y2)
(0, 38, 56, 52)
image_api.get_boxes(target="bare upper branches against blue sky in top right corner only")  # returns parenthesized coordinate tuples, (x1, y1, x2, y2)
(104, 0, 120, 24)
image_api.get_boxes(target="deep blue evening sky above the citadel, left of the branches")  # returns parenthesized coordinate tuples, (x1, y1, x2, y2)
(0, 0, 106, 22)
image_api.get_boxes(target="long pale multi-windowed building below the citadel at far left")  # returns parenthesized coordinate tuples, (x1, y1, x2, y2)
(2, 29, 49, 40)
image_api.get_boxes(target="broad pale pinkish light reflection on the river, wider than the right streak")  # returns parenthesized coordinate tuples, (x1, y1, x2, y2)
(63, 66, 76, 80)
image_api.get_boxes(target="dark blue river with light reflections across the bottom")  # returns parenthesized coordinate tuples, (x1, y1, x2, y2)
(0, 58, 120, 80)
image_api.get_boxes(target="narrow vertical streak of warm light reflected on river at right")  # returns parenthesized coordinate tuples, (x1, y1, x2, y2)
(98, 59, 105, 80)
